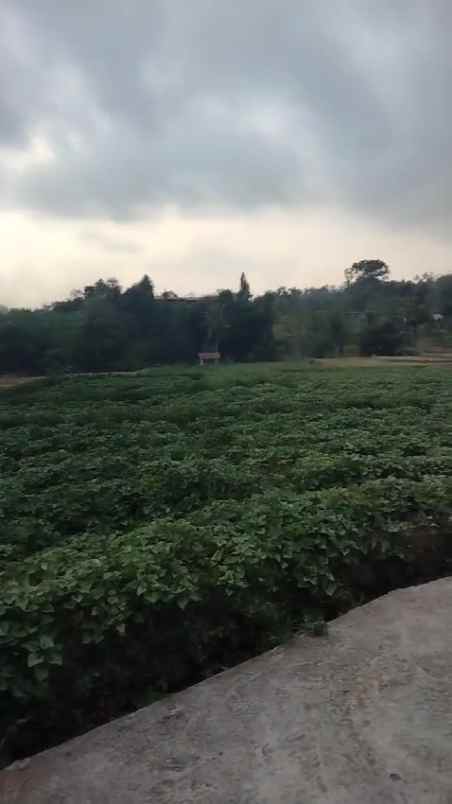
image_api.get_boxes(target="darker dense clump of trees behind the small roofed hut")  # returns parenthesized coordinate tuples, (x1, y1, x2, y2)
(0, 274, 274, 375)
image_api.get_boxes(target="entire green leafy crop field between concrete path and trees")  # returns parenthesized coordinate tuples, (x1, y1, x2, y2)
(0, 364, 452, 761)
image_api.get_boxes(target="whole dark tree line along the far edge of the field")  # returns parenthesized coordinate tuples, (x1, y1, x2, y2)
(0, 259, 452, 374)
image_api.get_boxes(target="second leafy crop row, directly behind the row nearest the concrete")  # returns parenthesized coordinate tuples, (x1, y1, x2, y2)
(4, 447, 452, 565)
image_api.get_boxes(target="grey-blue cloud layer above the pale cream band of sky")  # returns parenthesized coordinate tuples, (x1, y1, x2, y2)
(0, 0, 452, 232)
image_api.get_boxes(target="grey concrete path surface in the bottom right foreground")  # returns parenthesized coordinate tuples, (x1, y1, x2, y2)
(0, 578, 452, 804)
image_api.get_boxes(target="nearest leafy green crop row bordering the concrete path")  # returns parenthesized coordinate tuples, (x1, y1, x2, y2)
(0, 478, 452, 754)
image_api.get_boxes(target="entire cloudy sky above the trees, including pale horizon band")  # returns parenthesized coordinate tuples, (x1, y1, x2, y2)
(0, 0, 452, 306)
